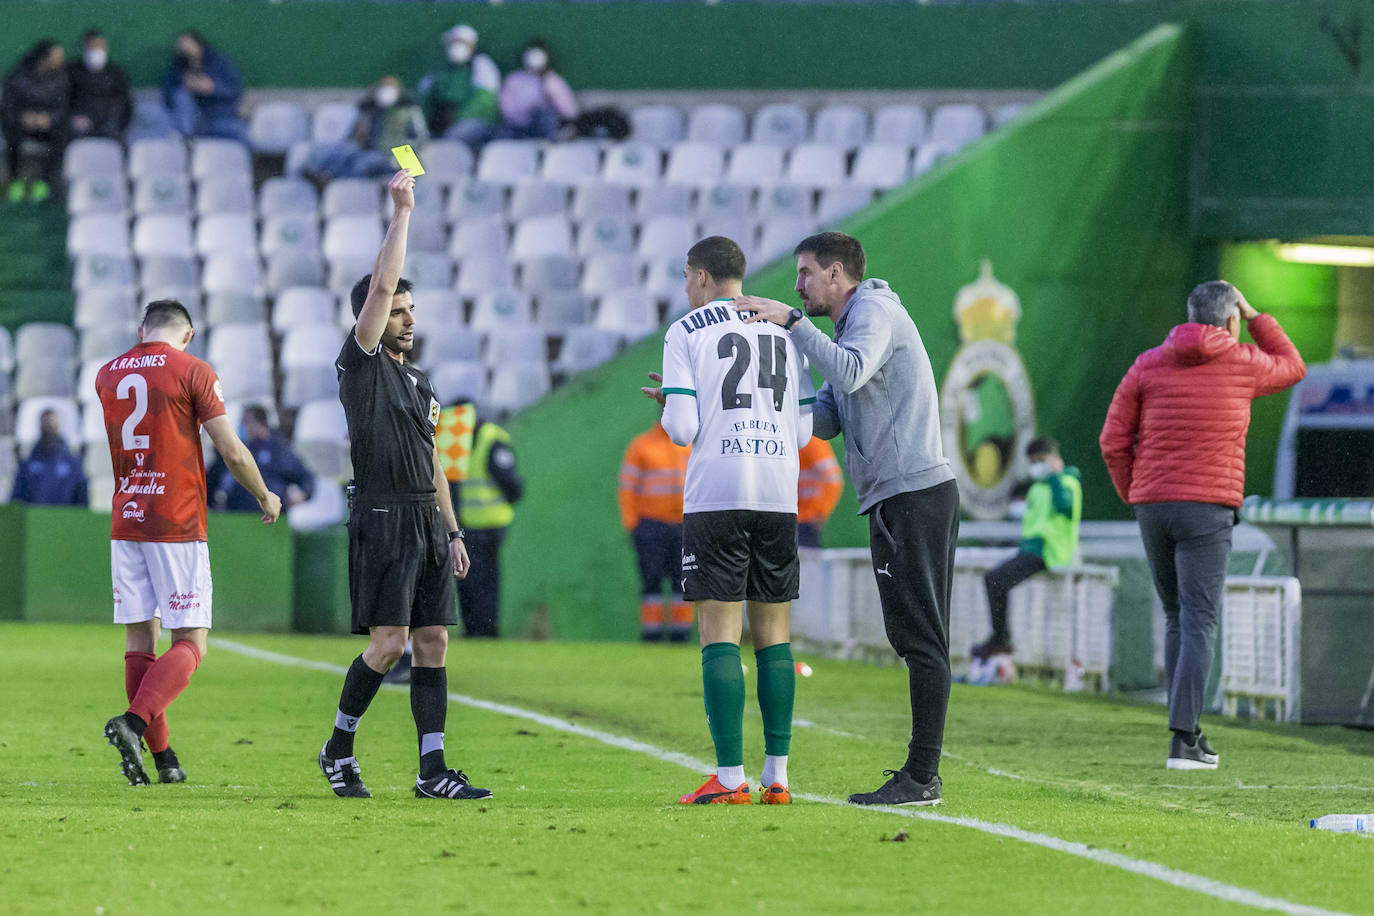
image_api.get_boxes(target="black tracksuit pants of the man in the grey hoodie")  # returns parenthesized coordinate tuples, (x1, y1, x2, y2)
(868, 481, 959, 780)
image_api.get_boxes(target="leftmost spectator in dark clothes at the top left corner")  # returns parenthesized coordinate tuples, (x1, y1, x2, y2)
(0, 38, 70, 203)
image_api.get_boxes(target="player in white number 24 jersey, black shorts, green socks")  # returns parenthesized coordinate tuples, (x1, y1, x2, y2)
(644, 236, 815, 805)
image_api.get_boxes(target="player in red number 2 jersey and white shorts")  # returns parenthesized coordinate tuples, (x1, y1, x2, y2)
(95, 299, 282, 786)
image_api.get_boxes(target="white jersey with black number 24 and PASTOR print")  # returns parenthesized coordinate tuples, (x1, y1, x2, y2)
(664, 299, 816, 514)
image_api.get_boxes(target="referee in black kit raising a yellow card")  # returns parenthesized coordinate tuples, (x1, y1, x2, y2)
(320, 169, 491, 798)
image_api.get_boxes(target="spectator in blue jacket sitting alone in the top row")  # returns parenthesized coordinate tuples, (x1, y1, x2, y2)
(162, 29, 249, 143)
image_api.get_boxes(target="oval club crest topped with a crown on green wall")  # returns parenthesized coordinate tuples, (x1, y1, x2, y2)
(940, 261, 1035, 519)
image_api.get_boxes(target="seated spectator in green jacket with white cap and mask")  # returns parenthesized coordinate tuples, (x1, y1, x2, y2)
(419, 25, 502, 148)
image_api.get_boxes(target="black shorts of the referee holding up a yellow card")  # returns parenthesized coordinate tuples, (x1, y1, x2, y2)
(348, 494, 458, 636)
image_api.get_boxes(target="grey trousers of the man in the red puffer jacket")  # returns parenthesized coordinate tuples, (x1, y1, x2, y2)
(1135, 503, 1235, 733)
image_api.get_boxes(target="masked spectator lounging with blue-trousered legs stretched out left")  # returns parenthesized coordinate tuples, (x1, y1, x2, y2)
(301, 77, 429, 181)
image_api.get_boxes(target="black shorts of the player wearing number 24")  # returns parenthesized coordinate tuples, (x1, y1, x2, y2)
(683, 509, 800, 604)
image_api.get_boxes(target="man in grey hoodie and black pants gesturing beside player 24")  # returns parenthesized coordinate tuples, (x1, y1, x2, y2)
(735, 232, 959, 805)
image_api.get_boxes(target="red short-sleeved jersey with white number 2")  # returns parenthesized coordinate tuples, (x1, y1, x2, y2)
(95, 343, 224, 541)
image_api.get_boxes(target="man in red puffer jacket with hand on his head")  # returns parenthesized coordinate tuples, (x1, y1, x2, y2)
(1099, 280, 1307, 769)
